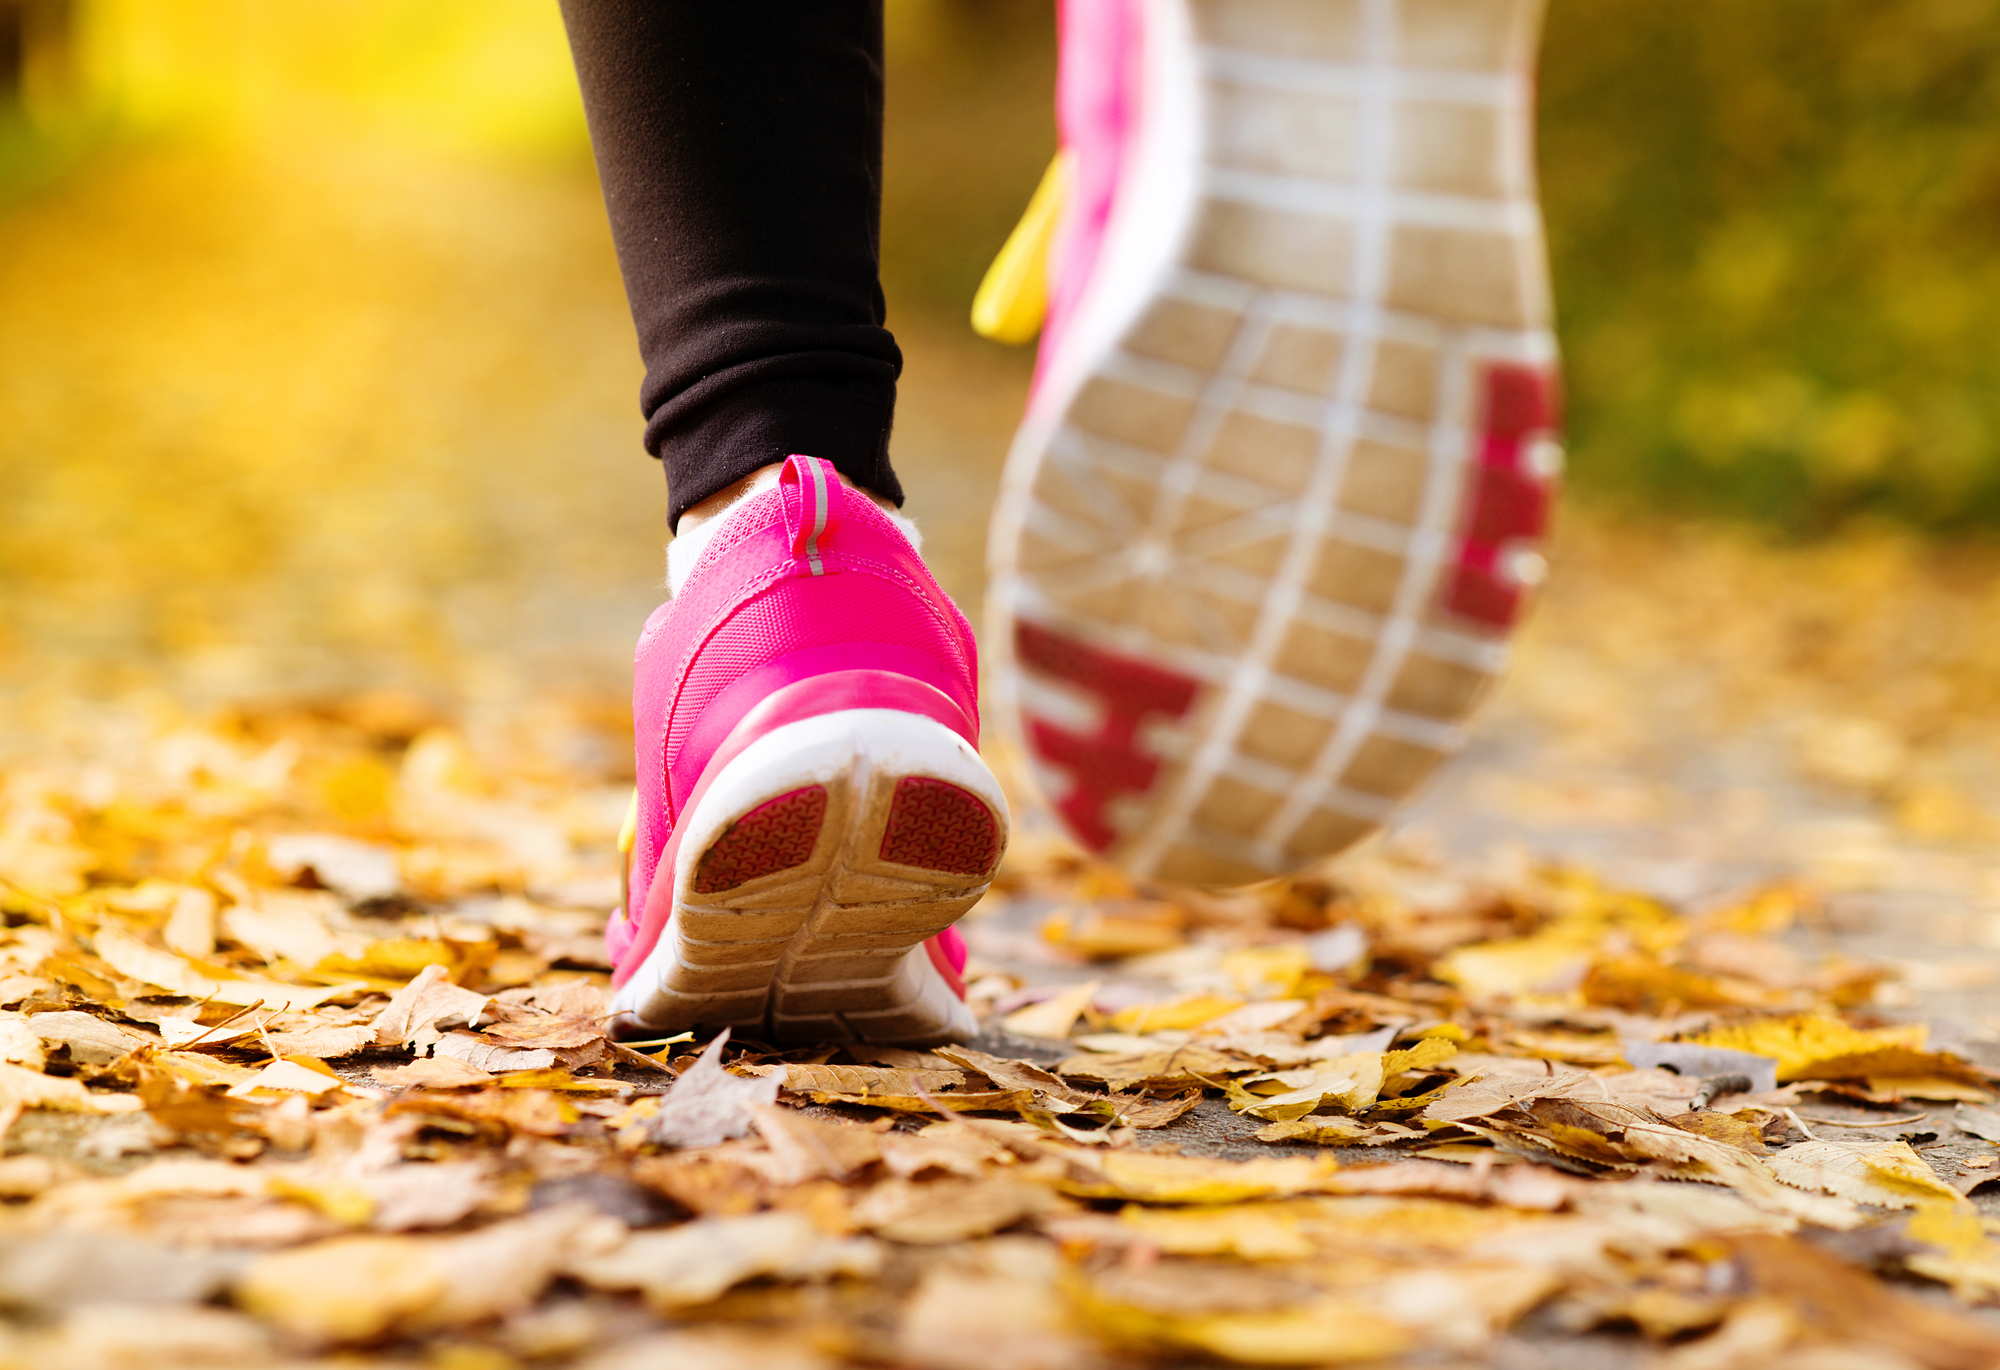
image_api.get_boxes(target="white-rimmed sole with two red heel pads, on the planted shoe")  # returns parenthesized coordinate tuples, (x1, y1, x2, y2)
(612, 708, 1008, 1044)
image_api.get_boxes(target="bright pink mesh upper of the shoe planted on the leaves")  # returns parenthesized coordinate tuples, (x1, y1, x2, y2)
(626, 456, 978, 922)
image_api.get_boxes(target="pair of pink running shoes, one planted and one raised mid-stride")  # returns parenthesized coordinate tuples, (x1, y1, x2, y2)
(606, 0, 1562, 1044)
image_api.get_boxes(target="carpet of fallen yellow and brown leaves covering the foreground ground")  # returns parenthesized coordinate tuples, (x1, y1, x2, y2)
(0, 698, 2000, 1370)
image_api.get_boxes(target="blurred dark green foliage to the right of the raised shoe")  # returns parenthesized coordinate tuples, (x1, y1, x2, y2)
(1542, 0, 2000, 532)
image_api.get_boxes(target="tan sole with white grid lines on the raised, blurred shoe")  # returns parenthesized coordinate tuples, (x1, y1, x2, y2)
(986, 0, 1562, 884)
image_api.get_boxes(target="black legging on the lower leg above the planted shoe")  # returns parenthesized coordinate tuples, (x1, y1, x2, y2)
(562, 0, 902, 522)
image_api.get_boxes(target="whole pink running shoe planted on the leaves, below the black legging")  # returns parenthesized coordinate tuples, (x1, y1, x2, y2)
(606, 456, 1008, 1044)
